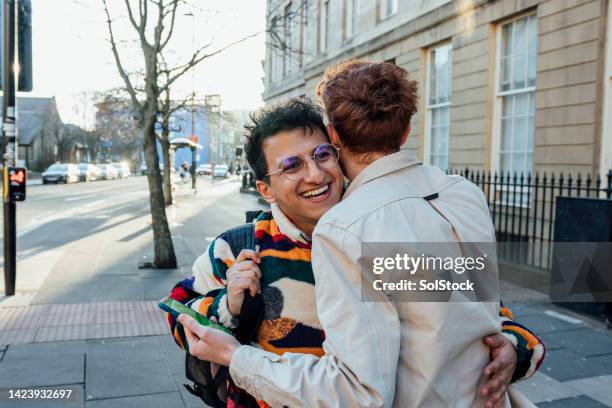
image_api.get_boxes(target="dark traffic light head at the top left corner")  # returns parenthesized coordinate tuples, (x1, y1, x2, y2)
(0, 0, 32, 92)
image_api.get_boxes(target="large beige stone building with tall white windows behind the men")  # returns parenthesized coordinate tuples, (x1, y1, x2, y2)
(263, 0, 612, 178)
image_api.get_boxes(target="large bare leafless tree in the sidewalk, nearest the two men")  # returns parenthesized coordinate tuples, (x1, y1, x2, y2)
(101, 0, 296, 268)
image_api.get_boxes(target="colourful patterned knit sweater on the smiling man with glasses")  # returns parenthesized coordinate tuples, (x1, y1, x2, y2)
(167, 205, 545, 381)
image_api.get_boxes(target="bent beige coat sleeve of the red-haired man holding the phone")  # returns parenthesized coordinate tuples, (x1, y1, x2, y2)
(230, 224, 401, 407)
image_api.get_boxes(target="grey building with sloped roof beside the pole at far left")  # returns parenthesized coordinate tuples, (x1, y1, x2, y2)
(17, 97, 66, 171)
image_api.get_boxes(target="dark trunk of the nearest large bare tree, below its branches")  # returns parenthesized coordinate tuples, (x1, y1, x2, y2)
(143, 99, 176, 269)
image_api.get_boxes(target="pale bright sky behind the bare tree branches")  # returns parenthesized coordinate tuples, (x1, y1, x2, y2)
(24, 0, 265, 126)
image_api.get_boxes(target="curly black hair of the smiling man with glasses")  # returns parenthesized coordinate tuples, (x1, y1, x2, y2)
(244, 98, 328, 180)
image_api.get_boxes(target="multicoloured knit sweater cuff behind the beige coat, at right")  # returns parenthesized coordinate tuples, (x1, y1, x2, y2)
(499, 303, 546, 382)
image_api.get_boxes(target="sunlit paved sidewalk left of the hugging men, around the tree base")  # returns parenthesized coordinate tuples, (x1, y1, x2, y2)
(0, 181, 261, 408)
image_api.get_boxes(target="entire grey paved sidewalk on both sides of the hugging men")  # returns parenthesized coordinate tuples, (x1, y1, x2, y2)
(0, 182, 612, 408)
